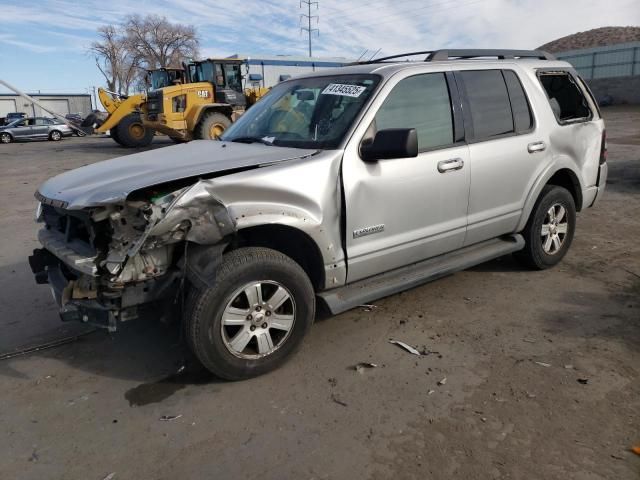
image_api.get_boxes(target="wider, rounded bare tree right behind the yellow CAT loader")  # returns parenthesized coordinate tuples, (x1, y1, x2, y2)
(124, 15, 200, 68)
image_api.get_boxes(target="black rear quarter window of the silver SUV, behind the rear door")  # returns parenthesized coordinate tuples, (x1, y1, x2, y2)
(540, 72, 591, 122)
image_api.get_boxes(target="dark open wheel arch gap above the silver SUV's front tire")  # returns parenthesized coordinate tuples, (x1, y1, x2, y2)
(225, 224, 325, 291)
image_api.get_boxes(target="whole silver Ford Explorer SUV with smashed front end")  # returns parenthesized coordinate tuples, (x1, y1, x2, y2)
(30, 50, 607, 379)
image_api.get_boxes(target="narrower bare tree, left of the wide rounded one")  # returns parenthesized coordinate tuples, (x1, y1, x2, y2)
(89, 25, 140, 95)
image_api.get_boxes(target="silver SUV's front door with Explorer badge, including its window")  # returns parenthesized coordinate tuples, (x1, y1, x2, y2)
(342, 73, 470, 282)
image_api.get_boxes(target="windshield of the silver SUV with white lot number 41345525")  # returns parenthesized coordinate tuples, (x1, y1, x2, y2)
(221, 74, 380, 149)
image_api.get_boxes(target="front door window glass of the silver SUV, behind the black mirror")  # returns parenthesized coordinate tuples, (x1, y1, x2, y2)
(375, 73, 453, 150)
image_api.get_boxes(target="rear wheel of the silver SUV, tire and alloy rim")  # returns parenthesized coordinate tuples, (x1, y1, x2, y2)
(515, 185, 576, 270)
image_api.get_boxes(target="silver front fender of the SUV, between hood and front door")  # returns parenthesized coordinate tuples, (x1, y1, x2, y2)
(195, 150, 347, 288)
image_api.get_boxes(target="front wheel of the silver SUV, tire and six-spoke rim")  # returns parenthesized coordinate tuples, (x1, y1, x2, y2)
(185, 247, 315, 380)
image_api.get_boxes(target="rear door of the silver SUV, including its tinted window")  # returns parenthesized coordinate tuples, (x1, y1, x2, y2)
(455, 69, 549, 245)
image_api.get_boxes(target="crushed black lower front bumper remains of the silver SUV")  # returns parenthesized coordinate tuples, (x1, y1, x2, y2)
(29, 248, 181, 332)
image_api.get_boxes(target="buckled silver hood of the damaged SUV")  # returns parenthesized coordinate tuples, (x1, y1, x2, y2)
(38, 140, 315, 209)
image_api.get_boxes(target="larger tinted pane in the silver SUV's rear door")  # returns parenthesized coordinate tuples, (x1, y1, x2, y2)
(458, 70, 513, 140)
